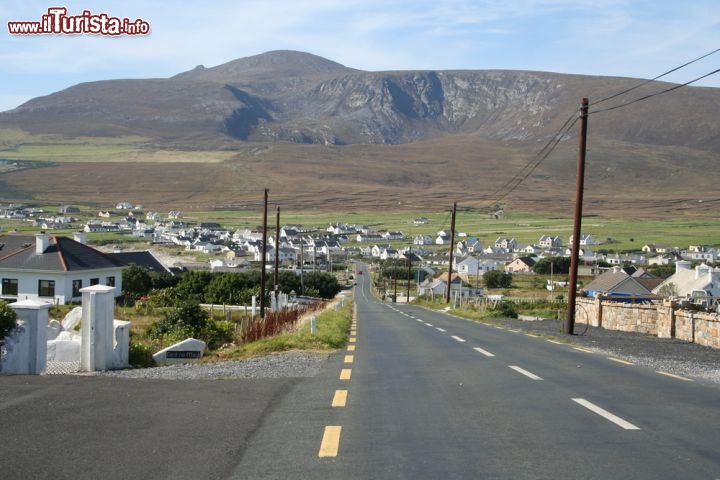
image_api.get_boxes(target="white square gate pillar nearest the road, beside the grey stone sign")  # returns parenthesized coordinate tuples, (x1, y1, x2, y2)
(80, 285, 115, 372)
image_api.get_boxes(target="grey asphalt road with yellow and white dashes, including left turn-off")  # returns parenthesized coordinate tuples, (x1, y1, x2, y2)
(0, 266, 720, 480)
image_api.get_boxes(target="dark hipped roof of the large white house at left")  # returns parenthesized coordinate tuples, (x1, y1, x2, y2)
(0, 234, 125, 272)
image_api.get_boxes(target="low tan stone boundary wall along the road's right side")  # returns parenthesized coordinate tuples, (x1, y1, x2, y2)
(575, 297, 720, 349)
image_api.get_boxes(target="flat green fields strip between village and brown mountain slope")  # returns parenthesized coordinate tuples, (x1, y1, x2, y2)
(0, 202, 720, 252)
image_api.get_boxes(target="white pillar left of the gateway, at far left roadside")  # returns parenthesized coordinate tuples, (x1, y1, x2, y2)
(10, 300, 52, 375)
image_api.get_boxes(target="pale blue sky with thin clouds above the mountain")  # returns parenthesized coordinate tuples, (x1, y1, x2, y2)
(0, 0, 720, 111)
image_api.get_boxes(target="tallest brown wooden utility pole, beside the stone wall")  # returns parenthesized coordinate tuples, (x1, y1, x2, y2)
(563, 98, 588, 335)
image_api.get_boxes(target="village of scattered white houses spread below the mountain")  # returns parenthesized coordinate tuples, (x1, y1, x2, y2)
(0, 202, 720, 305)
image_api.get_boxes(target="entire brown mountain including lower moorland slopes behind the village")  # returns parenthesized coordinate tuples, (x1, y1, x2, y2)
(0, 51, 720, 216)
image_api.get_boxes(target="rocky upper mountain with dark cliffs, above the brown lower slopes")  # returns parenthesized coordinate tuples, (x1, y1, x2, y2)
(0, 51, 720, 152)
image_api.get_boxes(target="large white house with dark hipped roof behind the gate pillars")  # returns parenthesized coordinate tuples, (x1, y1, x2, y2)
(0, 232, 126, 304)
